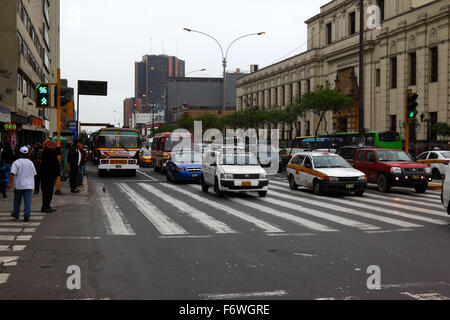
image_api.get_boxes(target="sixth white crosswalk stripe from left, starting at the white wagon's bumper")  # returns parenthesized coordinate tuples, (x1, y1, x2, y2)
(261, 191, 381, 231)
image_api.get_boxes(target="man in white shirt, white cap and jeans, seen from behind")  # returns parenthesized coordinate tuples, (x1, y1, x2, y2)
(10, 147, 36, 222)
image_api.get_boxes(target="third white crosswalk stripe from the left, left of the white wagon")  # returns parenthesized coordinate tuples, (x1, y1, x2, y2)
(139, 183, 236, 234)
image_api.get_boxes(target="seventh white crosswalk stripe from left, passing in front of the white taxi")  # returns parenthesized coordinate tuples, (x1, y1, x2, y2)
(272, 187, 423, 228)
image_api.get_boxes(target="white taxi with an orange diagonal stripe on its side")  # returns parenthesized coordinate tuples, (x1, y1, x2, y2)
(287, 152, 367, 196)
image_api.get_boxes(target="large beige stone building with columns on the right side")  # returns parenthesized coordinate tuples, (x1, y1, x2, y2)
(237, 0, 450, 150)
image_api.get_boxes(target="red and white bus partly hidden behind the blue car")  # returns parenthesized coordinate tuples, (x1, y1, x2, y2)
(151, 132, 192, 173)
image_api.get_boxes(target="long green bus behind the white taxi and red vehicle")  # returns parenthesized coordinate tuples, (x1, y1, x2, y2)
(294, 131, 403, 150)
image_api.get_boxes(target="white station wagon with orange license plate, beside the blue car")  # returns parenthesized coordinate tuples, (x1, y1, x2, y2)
(201, 149, 269, 197)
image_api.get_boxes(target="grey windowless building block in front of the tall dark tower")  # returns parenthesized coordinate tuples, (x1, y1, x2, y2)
(167, 72, 245, 123)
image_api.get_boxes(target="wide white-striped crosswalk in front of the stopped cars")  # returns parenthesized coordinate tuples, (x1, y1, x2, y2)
(96, 180, 450, 239)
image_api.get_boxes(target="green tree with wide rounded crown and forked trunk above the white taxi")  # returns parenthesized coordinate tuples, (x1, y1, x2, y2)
(299, 86, 353, 149)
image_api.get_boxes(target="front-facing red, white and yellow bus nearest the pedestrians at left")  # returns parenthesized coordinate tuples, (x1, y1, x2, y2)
(92, 128, 141, 176)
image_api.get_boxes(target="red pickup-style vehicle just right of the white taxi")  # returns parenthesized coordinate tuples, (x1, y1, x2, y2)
(353, 148, 432, 193)
